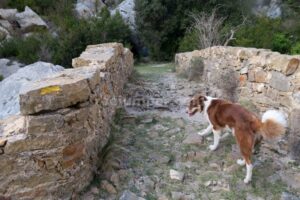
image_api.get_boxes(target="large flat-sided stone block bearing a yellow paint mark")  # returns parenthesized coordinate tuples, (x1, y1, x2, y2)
(20, 74, 91, 115)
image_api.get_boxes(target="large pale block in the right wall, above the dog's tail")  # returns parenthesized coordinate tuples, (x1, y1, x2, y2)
(270, 71, 290, 92)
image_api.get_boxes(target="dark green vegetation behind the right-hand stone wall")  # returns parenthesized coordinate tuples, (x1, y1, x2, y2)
(135, 0, 300, 60)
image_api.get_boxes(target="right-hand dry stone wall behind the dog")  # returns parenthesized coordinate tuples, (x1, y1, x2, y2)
(175, 46, 300, 158)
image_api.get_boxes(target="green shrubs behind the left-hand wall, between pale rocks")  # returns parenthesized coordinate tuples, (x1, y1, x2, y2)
(0, 0, 130, 67)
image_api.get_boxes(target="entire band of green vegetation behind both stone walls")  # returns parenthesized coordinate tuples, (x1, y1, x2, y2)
(0, 0, 300, 67)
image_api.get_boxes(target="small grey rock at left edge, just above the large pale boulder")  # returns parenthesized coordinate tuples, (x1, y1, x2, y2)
(0, 58, 22, 79)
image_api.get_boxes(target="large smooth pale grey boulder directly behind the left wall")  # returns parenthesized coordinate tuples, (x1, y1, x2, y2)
(0, 62, 64, 119)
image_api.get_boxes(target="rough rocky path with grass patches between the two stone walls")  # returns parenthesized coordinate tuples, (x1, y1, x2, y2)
(81, 64, 300, 200)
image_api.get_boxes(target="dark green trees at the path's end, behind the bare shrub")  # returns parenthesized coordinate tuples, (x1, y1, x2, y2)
(135, 0, 245, 61)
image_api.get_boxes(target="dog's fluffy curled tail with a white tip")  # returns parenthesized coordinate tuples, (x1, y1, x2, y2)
(259, 110, 287, 139)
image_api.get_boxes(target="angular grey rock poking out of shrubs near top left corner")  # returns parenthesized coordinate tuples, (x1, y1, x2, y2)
(16, 6, 48, 33)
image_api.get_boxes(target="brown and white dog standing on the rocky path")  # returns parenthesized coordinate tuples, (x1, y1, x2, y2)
(188, 94, 287, 183)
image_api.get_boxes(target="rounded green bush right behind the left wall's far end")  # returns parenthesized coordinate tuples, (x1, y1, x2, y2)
(49, 9, 130, 67)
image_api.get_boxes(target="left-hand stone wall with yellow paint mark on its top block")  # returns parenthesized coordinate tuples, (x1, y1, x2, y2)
(0, 43, 133, 199)
